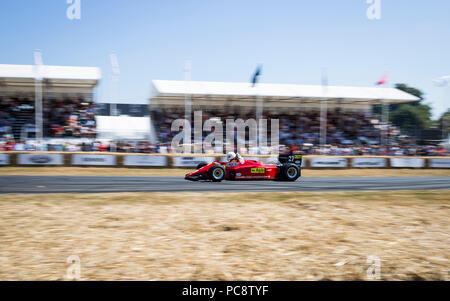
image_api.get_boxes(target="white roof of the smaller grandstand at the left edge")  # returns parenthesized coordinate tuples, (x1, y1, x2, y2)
(0, 64, 101, 80)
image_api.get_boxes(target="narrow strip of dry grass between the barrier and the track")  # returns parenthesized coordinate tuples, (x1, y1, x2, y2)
(0, 167, 450, 177)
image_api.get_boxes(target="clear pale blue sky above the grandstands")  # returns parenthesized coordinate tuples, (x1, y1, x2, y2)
(0, 0, 450, 117)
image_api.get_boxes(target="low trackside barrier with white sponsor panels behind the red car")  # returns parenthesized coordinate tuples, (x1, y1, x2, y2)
(0, 152, 450, 169)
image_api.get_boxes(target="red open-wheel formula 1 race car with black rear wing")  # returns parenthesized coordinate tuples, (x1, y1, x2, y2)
(185, 155, 302, 182)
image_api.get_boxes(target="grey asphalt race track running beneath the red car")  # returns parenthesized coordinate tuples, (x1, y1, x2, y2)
(0, 176, 450, 194)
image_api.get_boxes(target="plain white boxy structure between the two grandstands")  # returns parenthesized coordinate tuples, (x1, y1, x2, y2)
(95, 116, 150, 140)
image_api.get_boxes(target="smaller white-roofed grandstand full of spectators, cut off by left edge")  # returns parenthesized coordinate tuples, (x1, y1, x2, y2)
(0, 65, 101, 140)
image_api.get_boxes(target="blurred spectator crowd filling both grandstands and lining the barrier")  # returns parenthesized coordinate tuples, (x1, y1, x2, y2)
(0, 99, 449, 156)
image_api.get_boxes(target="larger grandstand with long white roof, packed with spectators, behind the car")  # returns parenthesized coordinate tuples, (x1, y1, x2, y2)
(150, 80, 419, 152)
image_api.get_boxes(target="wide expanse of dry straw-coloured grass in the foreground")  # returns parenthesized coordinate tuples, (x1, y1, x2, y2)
(0, 191, 450, 280)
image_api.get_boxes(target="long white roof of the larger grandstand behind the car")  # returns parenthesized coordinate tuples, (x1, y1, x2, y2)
(153, 80, 419, 102)
